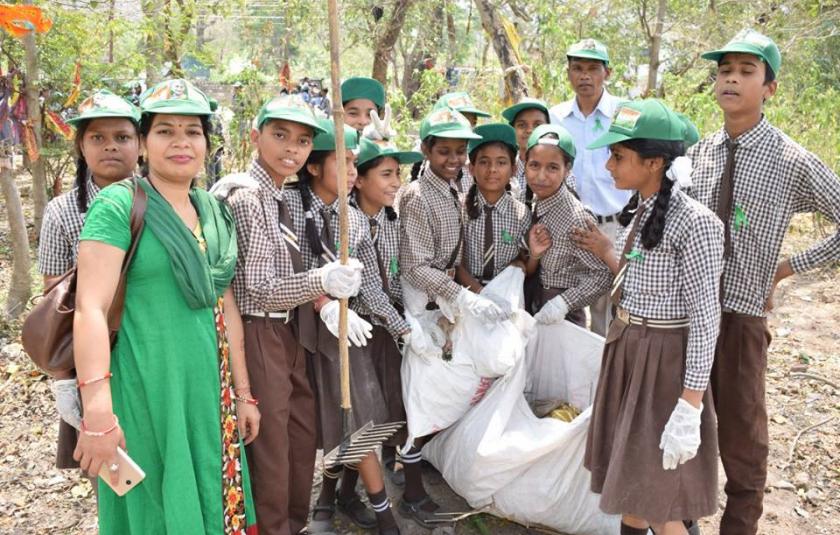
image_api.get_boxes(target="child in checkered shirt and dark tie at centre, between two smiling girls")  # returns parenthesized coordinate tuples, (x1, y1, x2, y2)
(456, 123, 536, 293)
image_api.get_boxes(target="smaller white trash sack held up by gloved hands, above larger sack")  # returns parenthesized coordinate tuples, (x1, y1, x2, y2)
(401, 267, 534, 444)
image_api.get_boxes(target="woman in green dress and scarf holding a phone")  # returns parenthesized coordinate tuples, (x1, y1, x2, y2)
(74, 80, 259, 535)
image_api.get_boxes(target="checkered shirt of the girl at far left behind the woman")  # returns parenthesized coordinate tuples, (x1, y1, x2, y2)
(38, 178, 99, 277)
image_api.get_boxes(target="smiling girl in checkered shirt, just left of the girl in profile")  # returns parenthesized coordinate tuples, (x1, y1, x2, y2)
(526, 125, 612, 327)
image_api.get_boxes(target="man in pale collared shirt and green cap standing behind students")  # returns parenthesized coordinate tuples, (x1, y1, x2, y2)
(549, 39, 630, 336)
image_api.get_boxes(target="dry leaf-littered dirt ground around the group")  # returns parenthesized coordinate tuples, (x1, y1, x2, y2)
(0, 172, 840, 535)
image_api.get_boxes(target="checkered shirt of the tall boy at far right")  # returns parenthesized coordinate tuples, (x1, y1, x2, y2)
(688, 118, 840, 316)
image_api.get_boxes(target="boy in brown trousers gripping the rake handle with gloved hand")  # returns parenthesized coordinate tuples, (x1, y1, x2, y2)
(219, 96, 361, 535)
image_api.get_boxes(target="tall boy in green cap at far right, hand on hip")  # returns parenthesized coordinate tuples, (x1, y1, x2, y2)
(689, 30, 840, 535)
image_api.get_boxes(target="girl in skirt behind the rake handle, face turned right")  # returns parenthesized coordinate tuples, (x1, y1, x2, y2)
(287, 121, 411, 534)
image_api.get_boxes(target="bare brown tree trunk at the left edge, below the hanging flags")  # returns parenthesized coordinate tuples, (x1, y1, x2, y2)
(0, 158, 32, 319)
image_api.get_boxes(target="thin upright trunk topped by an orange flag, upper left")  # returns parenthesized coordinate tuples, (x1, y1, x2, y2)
(23, 0, 47, 236)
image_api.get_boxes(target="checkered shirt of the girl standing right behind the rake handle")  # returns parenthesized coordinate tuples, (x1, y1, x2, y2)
(284, 184, 411, 338)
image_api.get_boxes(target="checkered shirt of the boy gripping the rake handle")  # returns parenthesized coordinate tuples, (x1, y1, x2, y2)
(227, 162, 324, 316)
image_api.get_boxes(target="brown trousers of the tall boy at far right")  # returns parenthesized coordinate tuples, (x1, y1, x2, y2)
(711, 312, 771, 535)
